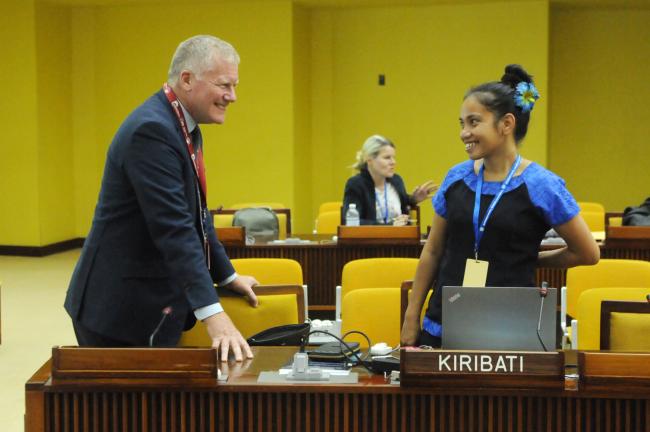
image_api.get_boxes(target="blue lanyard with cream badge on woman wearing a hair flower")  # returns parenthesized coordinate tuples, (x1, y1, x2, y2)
(463, 155, 521, 287)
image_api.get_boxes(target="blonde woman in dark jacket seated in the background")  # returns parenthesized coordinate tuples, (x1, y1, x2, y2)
(343, 135, 438, 226)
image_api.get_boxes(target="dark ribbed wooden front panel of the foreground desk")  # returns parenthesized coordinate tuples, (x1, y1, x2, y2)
(38, 386, 650, 432)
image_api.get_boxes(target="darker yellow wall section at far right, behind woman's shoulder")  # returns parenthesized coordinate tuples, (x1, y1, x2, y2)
(549, 8, 650, 211)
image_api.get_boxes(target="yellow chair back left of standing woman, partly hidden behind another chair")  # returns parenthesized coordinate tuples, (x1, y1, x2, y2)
(336, 258, 418, 320)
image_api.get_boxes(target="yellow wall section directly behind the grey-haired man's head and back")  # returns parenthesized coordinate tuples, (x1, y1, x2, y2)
(72, 1, 294, 236)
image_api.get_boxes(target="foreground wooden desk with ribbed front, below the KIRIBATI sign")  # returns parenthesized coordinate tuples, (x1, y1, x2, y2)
(25, 347, 650, 432)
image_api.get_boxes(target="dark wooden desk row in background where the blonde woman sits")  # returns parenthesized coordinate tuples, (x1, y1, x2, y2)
(224, 231, 650, 311)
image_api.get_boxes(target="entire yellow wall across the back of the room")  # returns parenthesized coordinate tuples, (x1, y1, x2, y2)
(0, 0, 650, 246)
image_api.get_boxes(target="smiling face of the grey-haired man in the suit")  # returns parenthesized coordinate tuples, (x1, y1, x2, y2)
(182, 59, 239, 124)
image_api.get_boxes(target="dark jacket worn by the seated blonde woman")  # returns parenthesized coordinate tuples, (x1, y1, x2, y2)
(341, 169, 417, 225)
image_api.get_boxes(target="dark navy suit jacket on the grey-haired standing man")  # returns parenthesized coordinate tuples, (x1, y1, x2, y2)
(65, 90, 234, 345)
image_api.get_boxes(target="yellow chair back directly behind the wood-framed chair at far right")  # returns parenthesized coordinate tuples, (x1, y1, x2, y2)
(571, 286, 650, 350)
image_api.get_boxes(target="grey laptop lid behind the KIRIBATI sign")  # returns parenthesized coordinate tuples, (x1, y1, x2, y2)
(442, 286, 557, 351)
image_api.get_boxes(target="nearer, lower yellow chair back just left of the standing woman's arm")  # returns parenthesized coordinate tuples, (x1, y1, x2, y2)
(341, 287, 401, 347)
